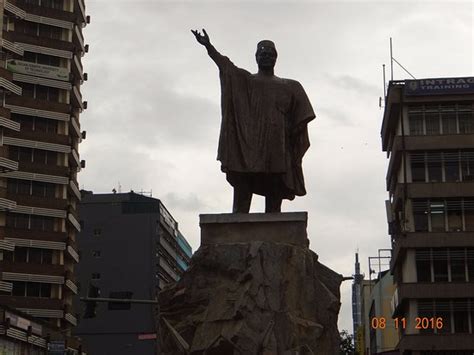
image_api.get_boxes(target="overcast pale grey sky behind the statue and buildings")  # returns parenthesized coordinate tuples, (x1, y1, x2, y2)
(79, 0, 474, 331)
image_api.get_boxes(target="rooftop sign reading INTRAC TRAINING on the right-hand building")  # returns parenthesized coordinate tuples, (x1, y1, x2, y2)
(405, 77, 474, 95)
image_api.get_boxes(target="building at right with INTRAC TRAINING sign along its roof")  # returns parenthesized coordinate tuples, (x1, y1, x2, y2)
(381, 77, 474, 355)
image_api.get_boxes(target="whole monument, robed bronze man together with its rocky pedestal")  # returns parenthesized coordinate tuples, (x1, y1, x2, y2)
(159, 31, 342, 355)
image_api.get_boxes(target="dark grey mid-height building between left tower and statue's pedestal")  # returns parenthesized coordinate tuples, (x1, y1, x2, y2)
(75, 191, 192, 355)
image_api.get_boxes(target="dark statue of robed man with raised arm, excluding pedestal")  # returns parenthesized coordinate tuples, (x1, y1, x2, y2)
(192, 29, 315, 213)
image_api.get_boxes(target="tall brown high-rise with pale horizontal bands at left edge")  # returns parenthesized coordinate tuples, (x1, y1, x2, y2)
(0, 0, 89, 348)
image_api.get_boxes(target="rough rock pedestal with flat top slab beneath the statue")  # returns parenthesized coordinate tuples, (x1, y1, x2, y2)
(160, 212, 342, 355)
